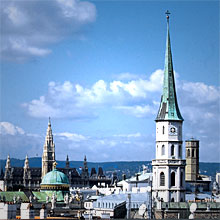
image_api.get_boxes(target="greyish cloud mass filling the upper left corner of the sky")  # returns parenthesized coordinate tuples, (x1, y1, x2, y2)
(0, 0, 96, 61)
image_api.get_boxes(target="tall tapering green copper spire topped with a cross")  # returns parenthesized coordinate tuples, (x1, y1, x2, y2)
(156, 11, 183, 121)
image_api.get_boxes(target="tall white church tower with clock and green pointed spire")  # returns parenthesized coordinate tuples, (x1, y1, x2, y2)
(152, 11, 185, 202)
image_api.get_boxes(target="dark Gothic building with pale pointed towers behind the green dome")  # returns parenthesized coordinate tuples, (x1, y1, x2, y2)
(1, 119, 111, 191)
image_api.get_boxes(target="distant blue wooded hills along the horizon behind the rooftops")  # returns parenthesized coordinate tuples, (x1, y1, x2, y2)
(0, 157, 220, 178)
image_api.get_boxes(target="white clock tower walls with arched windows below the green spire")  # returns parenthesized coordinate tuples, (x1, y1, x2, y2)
(152, 121, 185, 202)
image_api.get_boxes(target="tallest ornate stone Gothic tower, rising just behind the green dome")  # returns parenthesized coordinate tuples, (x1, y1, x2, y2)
(41, 118, 55, 178)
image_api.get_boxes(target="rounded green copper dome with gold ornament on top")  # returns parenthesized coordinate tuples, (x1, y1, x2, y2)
(41, 169, 69, 190)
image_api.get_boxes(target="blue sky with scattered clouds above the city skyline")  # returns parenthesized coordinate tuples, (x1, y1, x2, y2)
(0, 0, 220, 162)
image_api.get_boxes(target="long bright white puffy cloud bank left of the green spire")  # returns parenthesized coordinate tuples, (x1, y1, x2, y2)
(23, 70, 162, 118)
